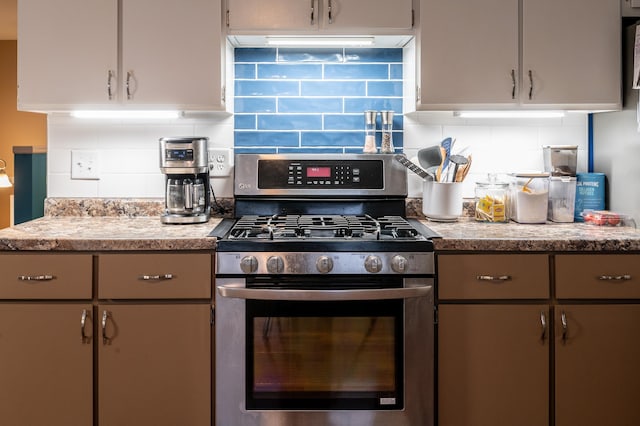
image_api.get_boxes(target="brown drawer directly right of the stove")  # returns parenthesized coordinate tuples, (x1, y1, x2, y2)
(438, 254, 549, 299)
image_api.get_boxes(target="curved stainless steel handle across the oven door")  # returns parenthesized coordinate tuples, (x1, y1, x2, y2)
(218, 284, 432, 302)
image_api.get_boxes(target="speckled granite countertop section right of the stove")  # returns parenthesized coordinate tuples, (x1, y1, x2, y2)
(422, 218, 640, 252)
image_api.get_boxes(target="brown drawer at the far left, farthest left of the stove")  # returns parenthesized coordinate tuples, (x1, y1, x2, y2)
(0, 253, 93, 299)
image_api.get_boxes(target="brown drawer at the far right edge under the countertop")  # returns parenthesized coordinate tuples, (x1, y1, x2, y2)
(556, 254, 640, 299)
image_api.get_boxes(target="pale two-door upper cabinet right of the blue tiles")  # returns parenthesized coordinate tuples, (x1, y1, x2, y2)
(416, 0, 621, 110)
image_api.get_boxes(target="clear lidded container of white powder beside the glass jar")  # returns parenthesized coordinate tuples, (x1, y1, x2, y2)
(508, 173, 549, 223)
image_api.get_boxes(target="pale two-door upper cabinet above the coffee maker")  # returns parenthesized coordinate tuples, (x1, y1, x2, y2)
(18, 0, 224, 111)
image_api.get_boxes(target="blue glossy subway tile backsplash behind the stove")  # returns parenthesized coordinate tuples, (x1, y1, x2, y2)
(234, 48, 403, 153)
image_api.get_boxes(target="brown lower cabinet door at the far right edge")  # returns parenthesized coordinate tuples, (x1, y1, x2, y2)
(555, 304, 640, 426)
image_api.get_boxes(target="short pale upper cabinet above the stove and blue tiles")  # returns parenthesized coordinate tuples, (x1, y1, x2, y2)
(227, 0, 413, 35)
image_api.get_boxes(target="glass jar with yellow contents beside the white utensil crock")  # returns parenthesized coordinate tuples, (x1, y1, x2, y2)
(475, 174, 509, 223)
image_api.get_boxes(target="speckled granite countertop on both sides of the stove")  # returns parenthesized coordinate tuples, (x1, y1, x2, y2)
(0, 199, 640, 252)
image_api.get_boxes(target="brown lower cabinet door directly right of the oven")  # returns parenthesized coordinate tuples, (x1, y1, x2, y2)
(438, 305, 552, 426)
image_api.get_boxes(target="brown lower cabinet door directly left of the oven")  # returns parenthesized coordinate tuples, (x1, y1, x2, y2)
(97, 304, 212, 426)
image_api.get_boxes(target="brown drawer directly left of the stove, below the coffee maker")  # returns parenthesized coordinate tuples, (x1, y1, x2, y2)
(98, 253, 212, 299)
